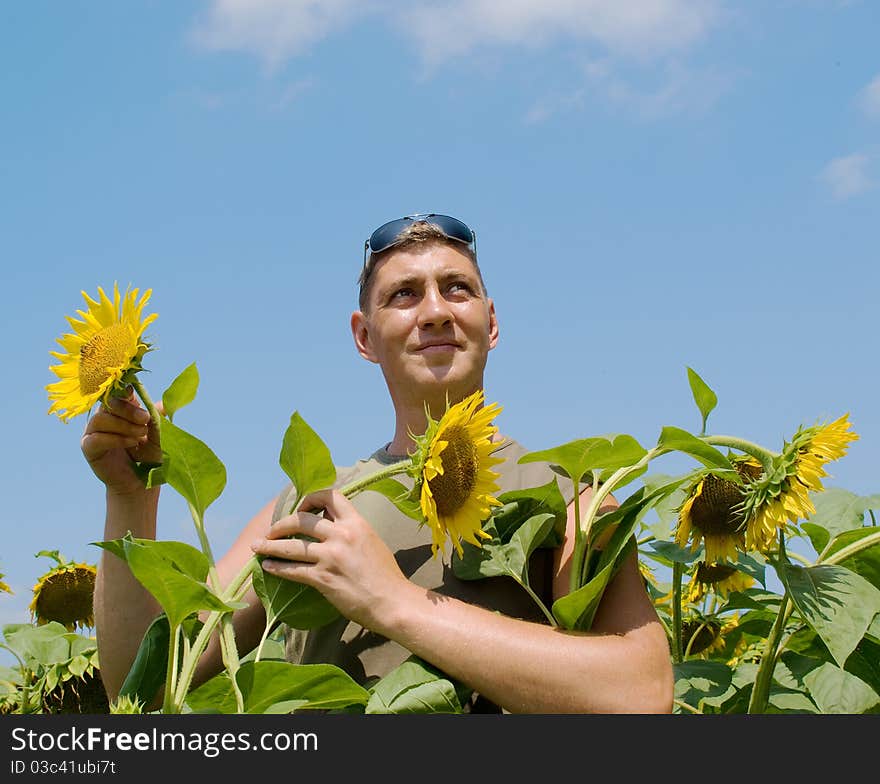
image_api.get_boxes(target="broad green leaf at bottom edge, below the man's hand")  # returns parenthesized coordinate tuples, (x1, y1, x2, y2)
(186, 661, 370, 713)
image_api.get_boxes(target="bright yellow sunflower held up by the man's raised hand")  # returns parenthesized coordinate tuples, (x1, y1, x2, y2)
(46, 283, 156, 422)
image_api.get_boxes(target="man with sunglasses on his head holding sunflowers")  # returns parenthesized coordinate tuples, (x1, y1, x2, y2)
(82, 214, 672, 713)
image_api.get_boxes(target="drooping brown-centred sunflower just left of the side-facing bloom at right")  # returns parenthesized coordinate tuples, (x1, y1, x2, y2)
(675, 460, 760, 563)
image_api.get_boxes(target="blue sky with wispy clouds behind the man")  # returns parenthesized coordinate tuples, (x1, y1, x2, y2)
(0, 0, 880, 648)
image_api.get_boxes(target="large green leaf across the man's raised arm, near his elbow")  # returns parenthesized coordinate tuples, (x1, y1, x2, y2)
(93, 534, 238, 626)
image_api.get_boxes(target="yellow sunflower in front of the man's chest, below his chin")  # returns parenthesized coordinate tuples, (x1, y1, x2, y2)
(413, 390, 504, 556)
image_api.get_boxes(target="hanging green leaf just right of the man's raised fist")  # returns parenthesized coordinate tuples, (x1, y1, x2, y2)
(160, 418, 226, 520)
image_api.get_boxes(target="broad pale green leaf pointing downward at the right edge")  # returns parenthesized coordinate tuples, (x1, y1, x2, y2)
(777, 563, 880, 667)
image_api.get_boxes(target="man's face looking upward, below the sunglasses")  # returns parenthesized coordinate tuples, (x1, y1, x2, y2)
(352, 243, 498, 416)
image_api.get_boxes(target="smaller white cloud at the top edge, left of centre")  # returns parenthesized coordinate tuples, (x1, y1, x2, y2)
(193, 0, 365, 69)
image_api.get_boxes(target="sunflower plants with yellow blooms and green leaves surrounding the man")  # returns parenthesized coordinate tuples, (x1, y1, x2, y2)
(0, 289, 880, 714)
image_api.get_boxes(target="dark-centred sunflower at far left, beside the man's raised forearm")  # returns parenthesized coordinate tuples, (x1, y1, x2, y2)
(29, 552, 97, 631)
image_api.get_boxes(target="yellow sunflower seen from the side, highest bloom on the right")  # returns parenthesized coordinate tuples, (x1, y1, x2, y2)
(745, 414, 859, 551)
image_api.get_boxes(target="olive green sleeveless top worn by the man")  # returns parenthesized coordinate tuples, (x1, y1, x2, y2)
(272, 440, 573, 711)
